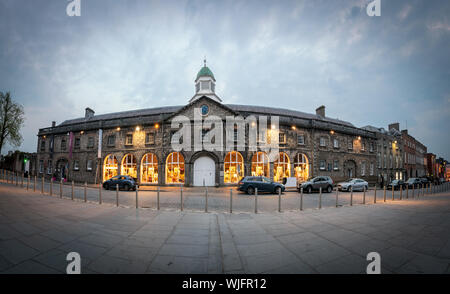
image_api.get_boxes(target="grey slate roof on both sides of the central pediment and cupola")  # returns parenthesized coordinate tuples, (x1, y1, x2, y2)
(59, 104, 354, 127)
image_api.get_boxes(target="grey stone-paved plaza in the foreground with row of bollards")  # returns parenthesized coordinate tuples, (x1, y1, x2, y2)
(0, 182, 450, 274)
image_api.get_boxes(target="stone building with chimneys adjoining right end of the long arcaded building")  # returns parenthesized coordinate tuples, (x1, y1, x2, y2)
(364, 123, 405, 184)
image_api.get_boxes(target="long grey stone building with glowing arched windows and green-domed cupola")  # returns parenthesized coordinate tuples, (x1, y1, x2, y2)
(37, 63, 377, 186)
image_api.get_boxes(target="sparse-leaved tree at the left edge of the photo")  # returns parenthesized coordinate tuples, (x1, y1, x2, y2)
(0, 92, 24, 153)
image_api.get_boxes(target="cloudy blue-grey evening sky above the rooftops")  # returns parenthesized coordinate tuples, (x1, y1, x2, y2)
(0, 0, 450, 159)
